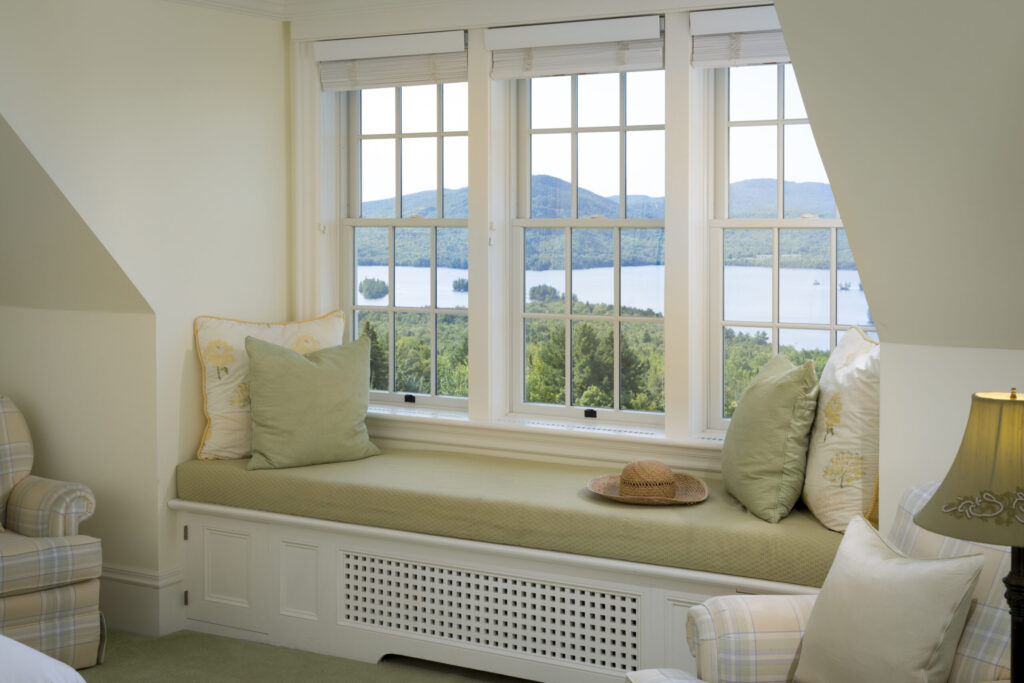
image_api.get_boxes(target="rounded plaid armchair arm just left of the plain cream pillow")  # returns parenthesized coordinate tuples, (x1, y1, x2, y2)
(686, 595, 816, 683)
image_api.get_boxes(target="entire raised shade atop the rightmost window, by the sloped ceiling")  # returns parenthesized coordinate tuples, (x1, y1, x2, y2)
(690, 5, 790, 69)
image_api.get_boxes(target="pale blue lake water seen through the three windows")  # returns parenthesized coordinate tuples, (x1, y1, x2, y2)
(355, 265, 871, 348)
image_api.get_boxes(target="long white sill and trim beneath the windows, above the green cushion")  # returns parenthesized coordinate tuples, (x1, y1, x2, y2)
(367, 404, 723, 476)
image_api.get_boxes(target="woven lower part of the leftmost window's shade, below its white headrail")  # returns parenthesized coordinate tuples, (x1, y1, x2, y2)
(319, 52, 468, 91)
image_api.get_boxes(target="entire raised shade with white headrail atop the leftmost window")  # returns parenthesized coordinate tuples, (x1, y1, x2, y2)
(313, 31, 468, 91)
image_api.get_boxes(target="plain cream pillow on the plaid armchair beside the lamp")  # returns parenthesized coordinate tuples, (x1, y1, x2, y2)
(795, 516, 984, 683)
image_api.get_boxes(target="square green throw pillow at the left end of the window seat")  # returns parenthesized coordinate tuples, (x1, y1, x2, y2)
(246, 337, 380, 470)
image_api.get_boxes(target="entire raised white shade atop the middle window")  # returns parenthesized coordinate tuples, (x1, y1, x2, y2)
(484, 16, 665, 80)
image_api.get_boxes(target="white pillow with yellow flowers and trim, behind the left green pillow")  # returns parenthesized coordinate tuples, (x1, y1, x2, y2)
(195, 310, 345, 460)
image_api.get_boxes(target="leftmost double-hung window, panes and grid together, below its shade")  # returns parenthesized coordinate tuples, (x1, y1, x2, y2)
(344, 82, 469, 398)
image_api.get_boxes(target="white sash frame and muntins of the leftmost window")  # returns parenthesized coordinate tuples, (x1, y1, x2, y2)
(338, 83, 470, 411)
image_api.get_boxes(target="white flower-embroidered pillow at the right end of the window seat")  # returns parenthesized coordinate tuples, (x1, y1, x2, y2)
(804, 328, 881, 531)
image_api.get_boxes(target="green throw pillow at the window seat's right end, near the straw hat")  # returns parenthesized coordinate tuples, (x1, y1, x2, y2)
(722, 355, 818, 523)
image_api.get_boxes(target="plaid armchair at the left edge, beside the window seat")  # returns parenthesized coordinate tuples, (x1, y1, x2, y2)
(0, 396, 105, 669)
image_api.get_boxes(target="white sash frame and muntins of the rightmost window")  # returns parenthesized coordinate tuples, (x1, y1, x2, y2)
(708, 63, 874, 430)
